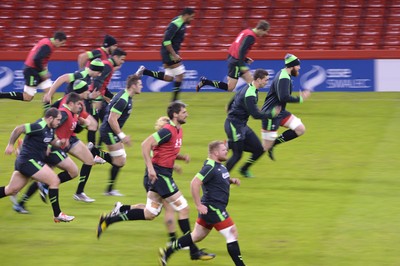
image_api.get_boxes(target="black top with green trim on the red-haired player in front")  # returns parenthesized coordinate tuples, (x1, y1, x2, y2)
(196, 158, 230, 208)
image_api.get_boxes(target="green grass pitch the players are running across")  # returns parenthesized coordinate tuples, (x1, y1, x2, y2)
(0, 91, 400, 266)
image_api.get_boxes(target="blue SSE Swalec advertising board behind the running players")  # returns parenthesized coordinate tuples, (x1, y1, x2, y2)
(0, 60, 375, 92)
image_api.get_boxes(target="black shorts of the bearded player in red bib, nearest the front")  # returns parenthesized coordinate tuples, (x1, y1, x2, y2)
(144, 164, 179, 199)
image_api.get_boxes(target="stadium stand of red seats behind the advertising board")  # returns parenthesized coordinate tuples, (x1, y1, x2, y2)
(0, 0, 400, 50)
